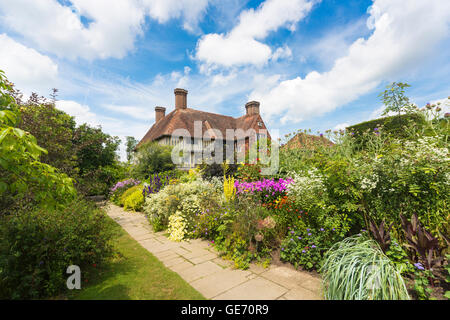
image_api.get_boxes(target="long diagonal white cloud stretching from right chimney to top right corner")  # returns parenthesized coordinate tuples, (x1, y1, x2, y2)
(251, 0, 450, 121)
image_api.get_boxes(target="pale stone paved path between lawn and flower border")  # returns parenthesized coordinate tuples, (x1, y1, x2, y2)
(106, 204, 322, 300)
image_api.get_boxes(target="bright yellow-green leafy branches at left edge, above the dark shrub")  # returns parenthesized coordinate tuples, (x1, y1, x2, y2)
(0, 71, 75, 212)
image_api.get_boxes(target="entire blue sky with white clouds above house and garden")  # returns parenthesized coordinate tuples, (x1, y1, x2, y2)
(0, 0, 450, 159)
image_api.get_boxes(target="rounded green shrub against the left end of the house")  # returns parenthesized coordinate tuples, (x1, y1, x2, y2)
(132, 142, 175, 180)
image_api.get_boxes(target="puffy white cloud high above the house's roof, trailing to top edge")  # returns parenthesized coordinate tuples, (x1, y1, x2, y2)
(195, 0, 315, 67)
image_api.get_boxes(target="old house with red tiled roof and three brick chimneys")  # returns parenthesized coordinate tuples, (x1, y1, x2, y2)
(136, 88, 270, 168)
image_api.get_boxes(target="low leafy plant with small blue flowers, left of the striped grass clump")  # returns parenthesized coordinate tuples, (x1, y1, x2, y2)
(280, 228, 342, 270)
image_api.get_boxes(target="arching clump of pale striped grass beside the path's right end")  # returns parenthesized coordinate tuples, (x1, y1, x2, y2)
(321, 236, 410, 300)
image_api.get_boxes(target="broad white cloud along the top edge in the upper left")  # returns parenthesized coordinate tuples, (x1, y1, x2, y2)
(0, 0, 208, 60)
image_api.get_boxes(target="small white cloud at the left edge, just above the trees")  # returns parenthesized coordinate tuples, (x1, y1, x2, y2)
(0, 34, 58, 96)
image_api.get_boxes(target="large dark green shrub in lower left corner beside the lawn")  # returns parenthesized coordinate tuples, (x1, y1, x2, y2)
(0, 199, 113, 299)
